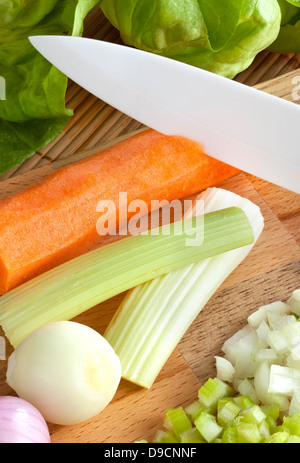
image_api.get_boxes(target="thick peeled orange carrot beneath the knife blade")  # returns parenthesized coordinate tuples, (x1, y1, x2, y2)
(0, 129, 238, 294)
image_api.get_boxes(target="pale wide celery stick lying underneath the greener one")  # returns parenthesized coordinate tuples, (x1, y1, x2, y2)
(104, 188, 264, 388)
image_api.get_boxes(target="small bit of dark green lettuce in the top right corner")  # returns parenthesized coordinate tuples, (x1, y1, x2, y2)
(270, 0, 300, 53)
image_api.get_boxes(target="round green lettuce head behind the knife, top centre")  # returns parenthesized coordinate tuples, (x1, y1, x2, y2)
(100, 0, 281, 78)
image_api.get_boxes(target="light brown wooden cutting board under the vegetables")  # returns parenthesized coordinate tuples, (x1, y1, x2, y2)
(0, 45, 300, 443)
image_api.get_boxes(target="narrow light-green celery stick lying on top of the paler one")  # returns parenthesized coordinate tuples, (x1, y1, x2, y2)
(0, 207, 254, 347)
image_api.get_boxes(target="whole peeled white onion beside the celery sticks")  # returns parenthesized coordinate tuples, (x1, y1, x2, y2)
(6, 321, 121, 425)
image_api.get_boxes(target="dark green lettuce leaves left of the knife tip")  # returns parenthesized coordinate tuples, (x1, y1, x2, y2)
(0, 0, 99, 174)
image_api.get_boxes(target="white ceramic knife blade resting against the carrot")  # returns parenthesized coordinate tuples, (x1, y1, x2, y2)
(30, 36, 300, 194)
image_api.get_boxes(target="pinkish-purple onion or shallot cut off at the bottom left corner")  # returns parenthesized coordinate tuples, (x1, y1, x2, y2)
(0, 396, 51, 444)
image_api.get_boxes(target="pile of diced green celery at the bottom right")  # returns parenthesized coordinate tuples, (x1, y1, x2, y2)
(143, 378, 300, 444)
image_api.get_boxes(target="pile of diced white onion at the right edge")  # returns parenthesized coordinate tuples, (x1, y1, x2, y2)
(217, 290, 300, 414)
